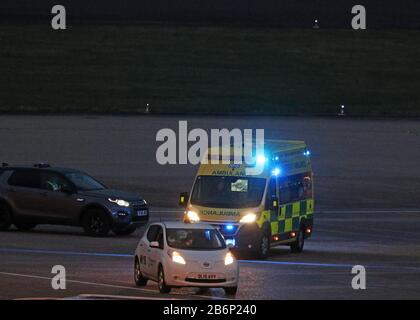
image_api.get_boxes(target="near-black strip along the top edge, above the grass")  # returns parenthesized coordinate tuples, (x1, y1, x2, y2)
(0, 0, 420, 28)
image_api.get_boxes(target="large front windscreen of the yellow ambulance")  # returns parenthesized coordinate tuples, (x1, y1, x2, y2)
(191, 176, 266, 208)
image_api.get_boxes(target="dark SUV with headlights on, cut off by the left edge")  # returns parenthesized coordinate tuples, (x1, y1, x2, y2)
(0, 163, 149, 236)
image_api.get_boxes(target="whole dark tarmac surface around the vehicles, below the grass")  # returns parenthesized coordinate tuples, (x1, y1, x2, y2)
(0, 116, 420, 299)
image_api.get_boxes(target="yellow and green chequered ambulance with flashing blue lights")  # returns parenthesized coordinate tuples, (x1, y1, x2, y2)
(180, 140, 314, 259)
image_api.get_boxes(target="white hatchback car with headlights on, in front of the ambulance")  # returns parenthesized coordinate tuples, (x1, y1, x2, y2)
(134, 222, 239, 295)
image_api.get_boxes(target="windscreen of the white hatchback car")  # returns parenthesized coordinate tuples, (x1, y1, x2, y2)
(166, 228, 226, 250)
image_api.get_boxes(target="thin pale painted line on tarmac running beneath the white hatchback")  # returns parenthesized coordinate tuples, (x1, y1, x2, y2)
(0, 271, 234, 300)
